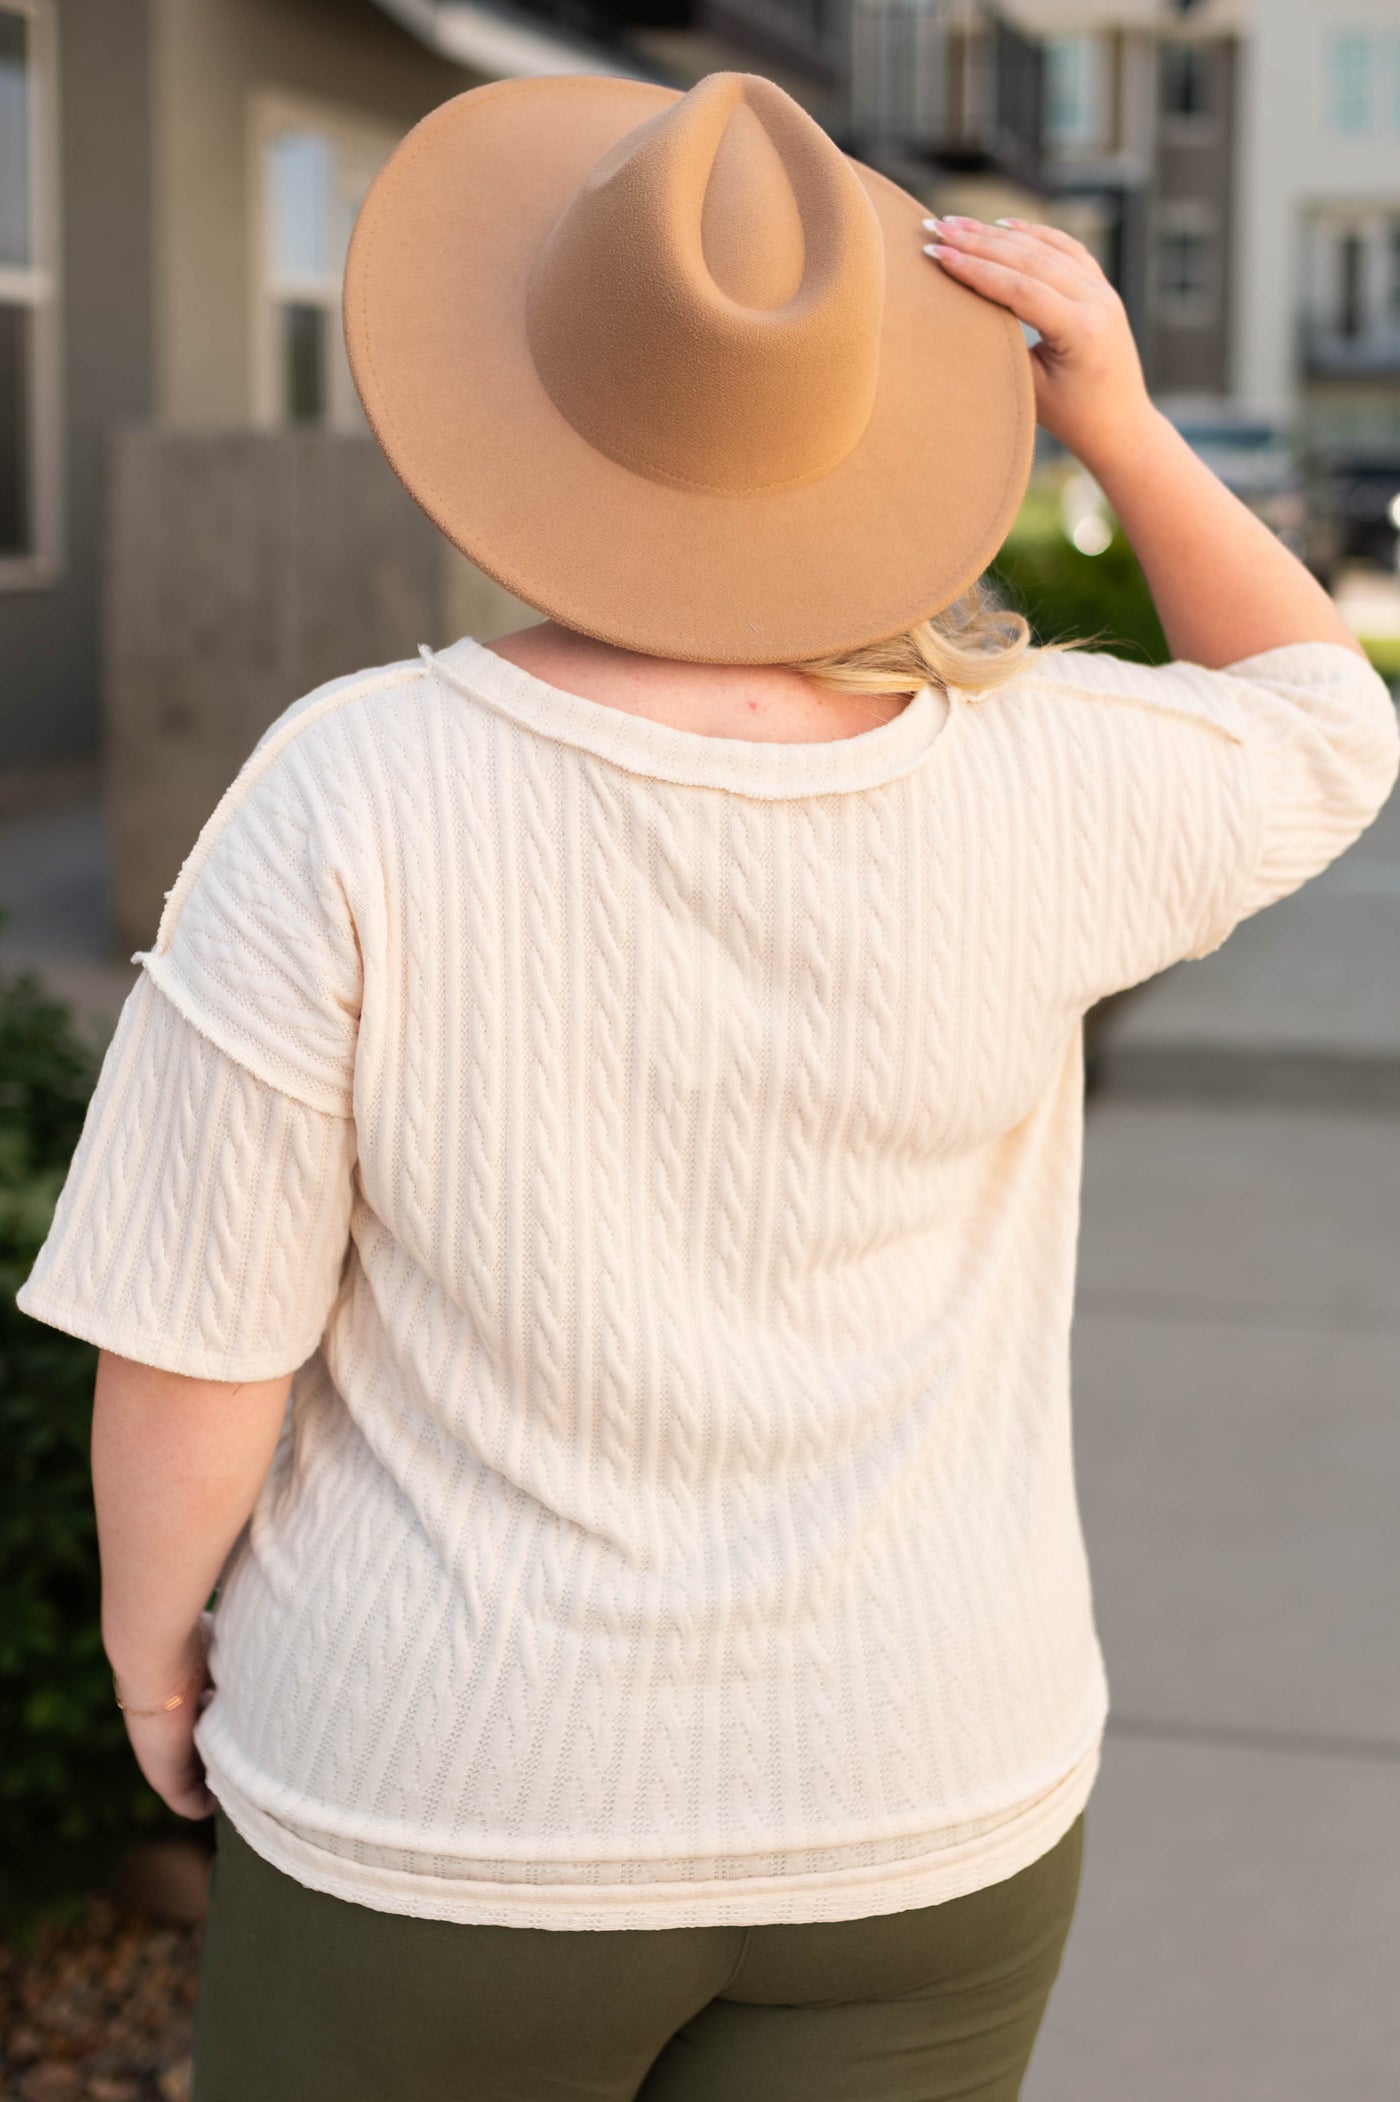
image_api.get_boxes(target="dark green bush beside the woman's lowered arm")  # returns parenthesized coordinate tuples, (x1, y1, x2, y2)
(0, 975, 178, 1923)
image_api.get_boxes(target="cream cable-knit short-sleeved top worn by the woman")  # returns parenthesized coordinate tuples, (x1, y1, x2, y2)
(19, 639, 1398, 1928)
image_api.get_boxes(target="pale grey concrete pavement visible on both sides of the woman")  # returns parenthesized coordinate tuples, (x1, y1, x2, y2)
(0, 765, 1400, 2102)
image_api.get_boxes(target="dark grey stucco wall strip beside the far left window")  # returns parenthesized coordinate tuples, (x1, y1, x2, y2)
(0, 0, 151, 769)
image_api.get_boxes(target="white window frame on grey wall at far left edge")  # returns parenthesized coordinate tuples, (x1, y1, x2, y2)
(0, 0, 67, 593)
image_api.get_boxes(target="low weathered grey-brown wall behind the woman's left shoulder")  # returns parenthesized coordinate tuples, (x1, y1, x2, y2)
(103, 431, 424, 948)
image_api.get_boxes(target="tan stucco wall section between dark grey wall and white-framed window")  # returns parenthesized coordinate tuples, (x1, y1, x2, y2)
(154, 0, 485, 429)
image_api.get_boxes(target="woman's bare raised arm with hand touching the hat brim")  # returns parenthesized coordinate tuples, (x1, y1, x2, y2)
(925, 219, 1364, 668)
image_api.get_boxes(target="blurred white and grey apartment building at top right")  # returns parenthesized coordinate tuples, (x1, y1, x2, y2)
(1013, 0, 1400, 563)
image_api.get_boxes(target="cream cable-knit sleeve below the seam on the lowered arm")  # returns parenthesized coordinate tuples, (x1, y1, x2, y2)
(19, 975, 355, 1379)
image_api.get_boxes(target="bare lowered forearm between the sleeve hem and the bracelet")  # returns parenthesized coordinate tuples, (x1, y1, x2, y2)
(92, 1352, 290, 1705)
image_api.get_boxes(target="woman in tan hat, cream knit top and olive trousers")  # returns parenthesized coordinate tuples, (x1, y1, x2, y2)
(21, 74, 1398, 2102)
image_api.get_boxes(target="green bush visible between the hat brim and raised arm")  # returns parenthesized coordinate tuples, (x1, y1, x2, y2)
(992, 490, 1171, 664)
